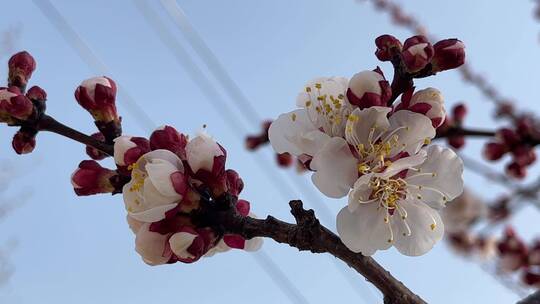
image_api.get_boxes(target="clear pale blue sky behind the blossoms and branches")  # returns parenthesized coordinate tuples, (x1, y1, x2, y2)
(0, 0, 540, 304)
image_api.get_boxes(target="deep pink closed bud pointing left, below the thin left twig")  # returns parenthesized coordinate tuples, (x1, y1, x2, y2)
(71, 160, 116, 196)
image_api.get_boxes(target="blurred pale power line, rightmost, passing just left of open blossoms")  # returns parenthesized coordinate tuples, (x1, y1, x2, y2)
(156, 0, 380, 300)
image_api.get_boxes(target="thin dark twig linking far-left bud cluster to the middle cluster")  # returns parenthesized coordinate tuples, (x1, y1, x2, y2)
(36, 115, 114, 156)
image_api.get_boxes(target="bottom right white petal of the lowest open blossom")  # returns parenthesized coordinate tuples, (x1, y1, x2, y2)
(391, 200, 444, 256)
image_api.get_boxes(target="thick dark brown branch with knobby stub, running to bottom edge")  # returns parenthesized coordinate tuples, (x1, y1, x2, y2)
(204, 200, 426, 304)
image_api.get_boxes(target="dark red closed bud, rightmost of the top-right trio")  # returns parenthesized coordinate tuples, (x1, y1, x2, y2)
(431, 39, 465, 72)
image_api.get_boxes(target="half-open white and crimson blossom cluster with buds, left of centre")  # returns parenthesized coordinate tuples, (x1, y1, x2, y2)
(71, 77, 262, 265)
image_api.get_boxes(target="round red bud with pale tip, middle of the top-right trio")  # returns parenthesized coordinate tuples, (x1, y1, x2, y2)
(401, 35, 433, 73)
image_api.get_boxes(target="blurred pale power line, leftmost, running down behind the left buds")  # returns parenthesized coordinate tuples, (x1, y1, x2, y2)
(33, 0, 308, 304)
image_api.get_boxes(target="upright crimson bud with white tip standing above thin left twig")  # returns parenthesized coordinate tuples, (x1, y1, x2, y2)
(75, 77, 119, 123)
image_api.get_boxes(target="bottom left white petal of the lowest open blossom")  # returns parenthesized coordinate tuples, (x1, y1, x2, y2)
(336, 203, 392, 256)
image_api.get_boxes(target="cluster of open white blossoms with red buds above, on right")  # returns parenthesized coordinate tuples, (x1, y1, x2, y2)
(268, 35, 463, 256)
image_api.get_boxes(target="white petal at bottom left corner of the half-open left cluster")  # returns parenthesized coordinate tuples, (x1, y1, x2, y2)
(135, 224, 171, 265)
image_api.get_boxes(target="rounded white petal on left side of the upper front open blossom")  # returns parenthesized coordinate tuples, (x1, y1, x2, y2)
(310, 137, 358, 198)
